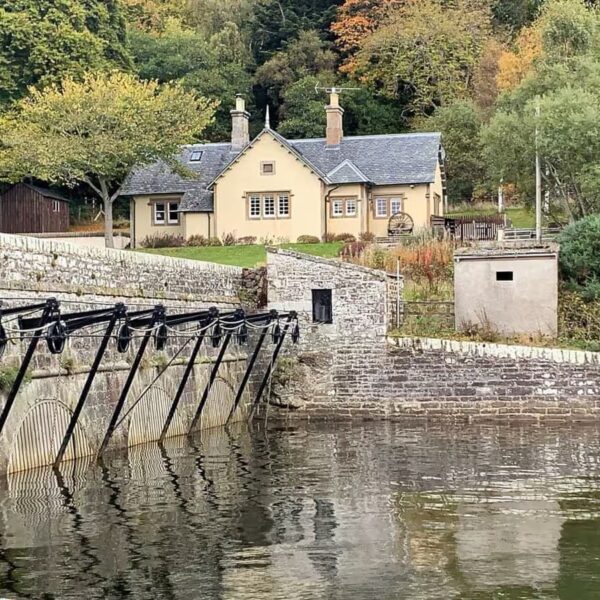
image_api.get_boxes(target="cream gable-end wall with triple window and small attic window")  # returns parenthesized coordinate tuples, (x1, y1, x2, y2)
(214, 133, 324, 242)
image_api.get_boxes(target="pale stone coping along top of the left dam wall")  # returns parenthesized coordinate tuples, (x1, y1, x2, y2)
(0, 233, 243, 275)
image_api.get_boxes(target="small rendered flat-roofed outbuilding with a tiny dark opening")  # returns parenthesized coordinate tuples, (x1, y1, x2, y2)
(454, 243, 558, 337)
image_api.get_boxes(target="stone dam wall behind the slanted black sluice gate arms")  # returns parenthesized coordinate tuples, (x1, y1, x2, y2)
(0, 235, 251, 471)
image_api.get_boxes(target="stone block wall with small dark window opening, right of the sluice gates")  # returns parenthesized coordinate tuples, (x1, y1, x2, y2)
(268, 251, 600, 420)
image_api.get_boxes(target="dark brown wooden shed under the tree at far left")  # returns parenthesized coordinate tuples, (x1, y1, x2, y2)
(0, 183, 70, 233)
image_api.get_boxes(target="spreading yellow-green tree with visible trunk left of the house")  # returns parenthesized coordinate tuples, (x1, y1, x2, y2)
(0, 73, 214, 247)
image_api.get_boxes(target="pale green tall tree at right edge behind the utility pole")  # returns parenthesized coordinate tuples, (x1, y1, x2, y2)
(482, 0, 600, 220)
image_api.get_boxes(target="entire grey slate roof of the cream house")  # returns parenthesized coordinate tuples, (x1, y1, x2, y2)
(121, 129, 442, 212)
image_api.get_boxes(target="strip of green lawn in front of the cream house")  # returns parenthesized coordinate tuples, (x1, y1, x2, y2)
(139, 242, 344, 267)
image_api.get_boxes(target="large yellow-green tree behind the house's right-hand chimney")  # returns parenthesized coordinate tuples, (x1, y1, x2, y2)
(355, 0, 490, 115)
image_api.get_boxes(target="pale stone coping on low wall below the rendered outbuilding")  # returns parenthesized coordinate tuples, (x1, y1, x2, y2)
(388, 336, 600, 366)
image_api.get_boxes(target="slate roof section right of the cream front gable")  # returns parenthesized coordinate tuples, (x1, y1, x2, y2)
(289, 133, 442, 185)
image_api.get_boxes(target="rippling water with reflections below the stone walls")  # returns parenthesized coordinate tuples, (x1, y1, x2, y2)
(0, 423, 600, 600)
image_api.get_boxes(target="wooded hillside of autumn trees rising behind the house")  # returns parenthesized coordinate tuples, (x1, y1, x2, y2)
(0, 0, 600, 217)
